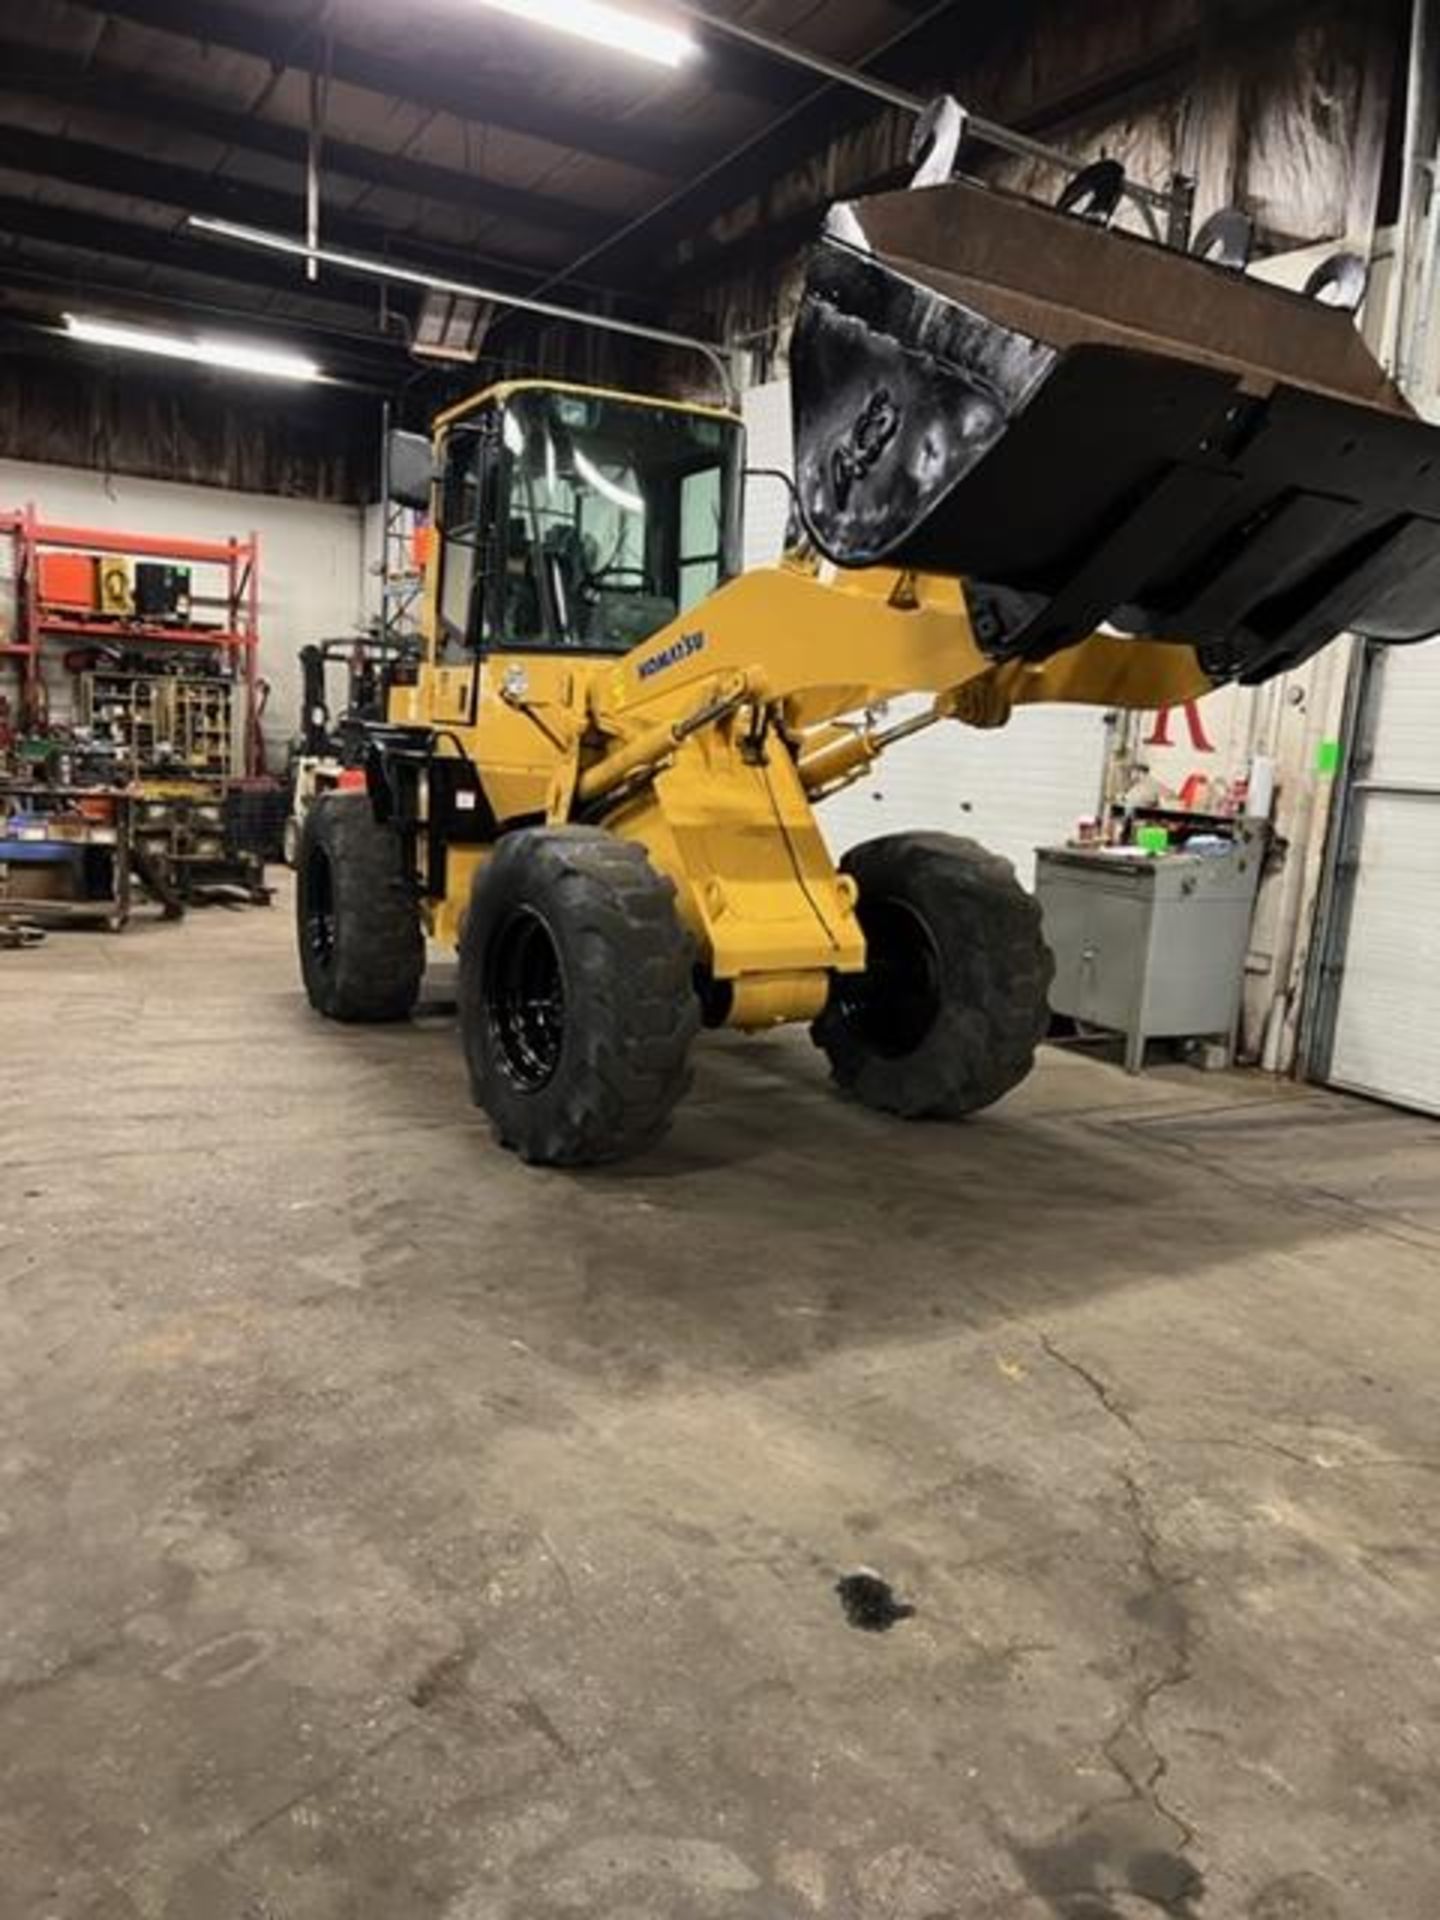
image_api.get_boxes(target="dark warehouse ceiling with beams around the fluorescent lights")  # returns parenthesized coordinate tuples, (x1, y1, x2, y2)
(0, 0, 973, 376)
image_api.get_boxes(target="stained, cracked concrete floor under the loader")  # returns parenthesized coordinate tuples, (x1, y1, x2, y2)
(0, 887, 1440, 1920)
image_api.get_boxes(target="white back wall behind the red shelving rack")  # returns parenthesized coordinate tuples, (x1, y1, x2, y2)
(0, 459, 376, 772)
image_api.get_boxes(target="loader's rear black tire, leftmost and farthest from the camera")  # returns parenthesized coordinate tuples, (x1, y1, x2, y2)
(296, 793, 424, 1021)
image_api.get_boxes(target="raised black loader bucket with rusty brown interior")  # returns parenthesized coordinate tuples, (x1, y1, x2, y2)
(791, 182, 1440, 682)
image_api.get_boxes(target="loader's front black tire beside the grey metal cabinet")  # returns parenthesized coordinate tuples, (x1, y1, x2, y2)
(810, 833, 1054, 1119)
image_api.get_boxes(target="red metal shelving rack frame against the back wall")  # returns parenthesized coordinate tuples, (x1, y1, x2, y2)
(0, 503, 259, 774)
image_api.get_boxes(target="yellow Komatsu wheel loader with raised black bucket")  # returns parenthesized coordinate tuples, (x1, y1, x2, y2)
(298, 142, 1440, 1165)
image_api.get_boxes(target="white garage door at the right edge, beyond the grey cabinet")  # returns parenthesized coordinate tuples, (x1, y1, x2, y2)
(1329, 641, 1440, 1114)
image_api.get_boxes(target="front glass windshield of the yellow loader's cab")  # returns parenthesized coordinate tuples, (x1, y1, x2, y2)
(499, 388, 739, 653)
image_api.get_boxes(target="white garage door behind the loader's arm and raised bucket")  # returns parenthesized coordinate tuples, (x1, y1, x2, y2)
(745, 380, 1106, 887)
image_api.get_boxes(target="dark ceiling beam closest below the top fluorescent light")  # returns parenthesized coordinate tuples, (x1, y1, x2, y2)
(67, 0, 721, 179)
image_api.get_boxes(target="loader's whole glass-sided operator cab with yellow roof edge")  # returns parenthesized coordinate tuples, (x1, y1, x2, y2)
(434, 382, 743, 664)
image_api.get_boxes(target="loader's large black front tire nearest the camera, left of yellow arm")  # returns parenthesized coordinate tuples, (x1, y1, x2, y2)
(459, 828, 699, 1167)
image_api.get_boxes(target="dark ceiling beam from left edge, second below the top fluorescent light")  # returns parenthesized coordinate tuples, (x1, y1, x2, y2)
(0, 40, 607, 238)
